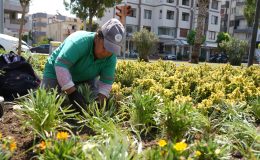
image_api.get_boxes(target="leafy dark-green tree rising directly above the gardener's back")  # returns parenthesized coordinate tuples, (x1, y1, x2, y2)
(63, 0, 122, 31)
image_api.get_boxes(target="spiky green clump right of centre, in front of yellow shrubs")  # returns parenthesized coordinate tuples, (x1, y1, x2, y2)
(156, 102, 209, 140)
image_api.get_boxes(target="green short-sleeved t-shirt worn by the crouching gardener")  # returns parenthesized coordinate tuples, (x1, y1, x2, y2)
(43, 31, 116, 84)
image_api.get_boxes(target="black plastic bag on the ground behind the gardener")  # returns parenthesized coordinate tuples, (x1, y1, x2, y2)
(0, 53, 40, 101)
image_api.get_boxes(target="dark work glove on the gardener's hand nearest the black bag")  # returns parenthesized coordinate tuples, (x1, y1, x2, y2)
(68, 90, 86, 114)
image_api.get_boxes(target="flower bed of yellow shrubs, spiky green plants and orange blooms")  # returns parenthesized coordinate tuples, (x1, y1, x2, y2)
(0, 61, 260, 160)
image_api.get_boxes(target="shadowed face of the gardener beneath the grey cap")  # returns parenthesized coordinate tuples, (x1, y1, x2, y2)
(94, 37, 112, 59)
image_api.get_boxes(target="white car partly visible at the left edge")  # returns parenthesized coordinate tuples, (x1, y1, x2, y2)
(0, 34, 30, 53)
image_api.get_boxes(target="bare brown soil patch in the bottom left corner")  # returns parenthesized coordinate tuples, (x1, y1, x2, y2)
(0, 105, 33, 160)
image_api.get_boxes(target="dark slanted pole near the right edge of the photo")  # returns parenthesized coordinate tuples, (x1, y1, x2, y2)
(247, 0, 260, 67)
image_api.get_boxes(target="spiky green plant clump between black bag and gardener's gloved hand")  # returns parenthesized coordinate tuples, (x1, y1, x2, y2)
(18, 88, 74, 136)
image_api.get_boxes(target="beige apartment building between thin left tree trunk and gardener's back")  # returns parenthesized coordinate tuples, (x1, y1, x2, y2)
(32, 13, 81, 43)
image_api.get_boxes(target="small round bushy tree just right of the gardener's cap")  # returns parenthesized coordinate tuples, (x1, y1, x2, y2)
(133, 29, 159, 62)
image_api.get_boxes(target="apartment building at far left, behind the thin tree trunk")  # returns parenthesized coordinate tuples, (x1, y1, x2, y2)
(4, 0, 30, 37)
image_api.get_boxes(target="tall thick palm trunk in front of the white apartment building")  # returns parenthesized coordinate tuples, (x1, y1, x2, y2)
(190, 0, 209, 63)
